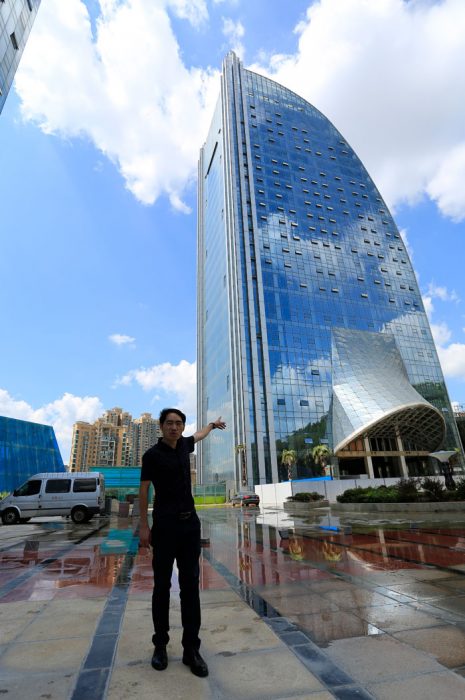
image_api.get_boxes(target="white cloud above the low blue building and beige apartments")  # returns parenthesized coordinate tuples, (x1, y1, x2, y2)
(0, 389, 103, 464)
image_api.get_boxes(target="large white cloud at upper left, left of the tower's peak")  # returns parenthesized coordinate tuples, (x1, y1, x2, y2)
(16, 0, 219, 211)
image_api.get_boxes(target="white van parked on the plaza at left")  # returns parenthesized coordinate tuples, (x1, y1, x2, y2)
(0, 472, 105, 525)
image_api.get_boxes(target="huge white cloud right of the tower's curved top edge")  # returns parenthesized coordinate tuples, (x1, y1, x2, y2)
(253, 0, 465, 220)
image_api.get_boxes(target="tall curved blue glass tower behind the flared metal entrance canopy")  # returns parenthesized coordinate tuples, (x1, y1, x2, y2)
(198, 54, 460, 486)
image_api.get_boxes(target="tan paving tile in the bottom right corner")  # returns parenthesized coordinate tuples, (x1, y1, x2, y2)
(367, 671, 465, 700)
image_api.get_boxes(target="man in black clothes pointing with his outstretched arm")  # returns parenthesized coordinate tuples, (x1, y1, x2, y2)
(139, 408, 226, 678)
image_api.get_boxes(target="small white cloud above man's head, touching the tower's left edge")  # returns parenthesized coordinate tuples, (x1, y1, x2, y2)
(116, 360, 197, 416)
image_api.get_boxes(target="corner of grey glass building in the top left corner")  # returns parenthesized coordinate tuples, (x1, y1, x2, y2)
(0, 0, 40, 112)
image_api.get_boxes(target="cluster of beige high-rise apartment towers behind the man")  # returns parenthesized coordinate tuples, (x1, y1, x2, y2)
(70, 408, 161, 471)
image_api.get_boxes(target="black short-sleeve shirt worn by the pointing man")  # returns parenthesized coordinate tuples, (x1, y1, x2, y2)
(140, 435, 194, 515)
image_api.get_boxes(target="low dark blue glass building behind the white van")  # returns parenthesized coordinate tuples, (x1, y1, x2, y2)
(0, 416, 65, 492)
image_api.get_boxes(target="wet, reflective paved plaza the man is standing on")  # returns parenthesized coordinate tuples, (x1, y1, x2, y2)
(0, 508, 465, 700)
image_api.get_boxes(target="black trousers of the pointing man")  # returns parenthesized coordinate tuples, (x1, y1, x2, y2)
(152, 511, 200, 649)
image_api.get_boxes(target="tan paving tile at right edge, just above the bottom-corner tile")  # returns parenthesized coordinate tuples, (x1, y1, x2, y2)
(394, 625, 465, 668)
